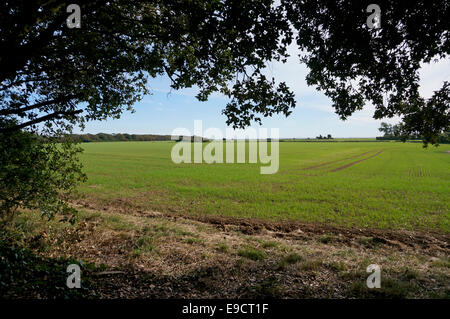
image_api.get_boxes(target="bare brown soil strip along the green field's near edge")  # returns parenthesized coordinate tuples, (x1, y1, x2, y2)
(74, 201, 450, 254)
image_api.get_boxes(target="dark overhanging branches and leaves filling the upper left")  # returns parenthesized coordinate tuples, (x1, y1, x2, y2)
(0, 0, 295, 132)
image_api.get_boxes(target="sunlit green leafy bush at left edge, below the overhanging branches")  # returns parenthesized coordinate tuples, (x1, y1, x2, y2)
(0, 119, 85, 224)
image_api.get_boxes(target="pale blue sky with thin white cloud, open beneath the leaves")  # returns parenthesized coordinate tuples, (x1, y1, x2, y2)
(74, 46, 450, 138)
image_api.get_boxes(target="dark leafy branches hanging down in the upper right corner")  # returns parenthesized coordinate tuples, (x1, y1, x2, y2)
(282, 0, 450, 144)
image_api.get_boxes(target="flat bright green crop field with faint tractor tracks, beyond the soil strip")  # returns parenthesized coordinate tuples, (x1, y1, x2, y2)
(79, 142, 450, 233)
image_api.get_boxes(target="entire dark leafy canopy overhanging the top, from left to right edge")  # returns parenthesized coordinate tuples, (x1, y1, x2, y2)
(0, 0, 450, 143)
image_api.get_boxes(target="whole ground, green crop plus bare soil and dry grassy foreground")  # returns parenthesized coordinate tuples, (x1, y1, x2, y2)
(7, 141, 450, 298)
